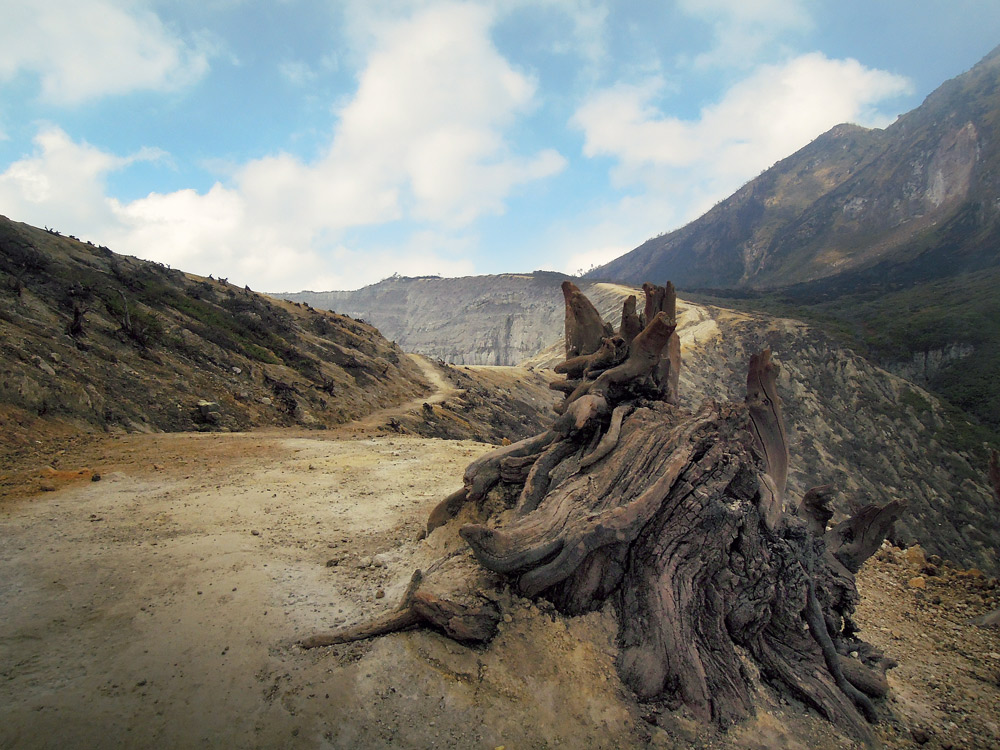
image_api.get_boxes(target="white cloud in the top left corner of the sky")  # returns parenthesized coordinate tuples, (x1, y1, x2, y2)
(0, 0, 209, 105)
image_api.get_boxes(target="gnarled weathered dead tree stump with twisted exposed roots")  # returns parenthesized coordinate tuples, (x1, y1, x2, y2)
(303, 282, 903, 741)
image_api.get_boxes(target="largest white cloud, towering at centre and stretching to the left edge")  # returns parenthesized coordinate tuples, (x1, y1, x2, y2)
(0, 3, 565, 290)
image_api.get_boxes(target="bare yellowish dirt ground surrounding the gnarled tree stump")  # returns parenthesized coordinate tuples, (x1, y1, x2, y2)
(0, 376, 1000, 749)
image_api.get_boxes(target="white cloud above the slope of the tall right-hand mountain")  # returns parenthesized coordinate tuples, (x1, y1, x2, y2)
(572, 53, 910, 198)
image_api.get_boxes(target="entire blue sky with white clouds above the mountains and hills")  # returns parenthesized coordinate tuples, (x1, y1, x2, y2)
(0, 0, 1000, 291)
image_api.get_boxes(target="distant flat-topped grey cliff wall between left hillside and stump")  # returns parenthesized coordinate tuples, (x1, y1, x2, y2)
(275, 271, 624, 365)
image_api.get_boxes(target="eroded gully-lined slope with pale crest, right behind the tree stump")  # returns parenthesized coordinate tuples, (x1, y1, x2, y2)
(681, 306, 1000, 574)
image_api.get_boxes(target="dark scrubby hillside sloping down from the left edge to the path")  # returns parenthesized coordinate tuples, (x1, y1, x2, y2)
(0, 217, 427, 440)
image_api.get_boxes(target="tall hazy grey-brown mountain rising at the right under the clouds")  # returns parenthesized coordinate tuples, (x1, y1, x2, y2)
(587, 43, 1000, 289)
